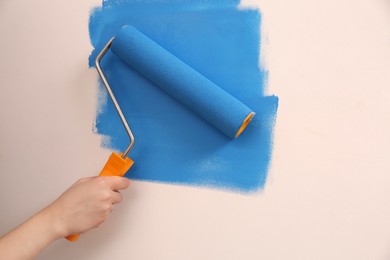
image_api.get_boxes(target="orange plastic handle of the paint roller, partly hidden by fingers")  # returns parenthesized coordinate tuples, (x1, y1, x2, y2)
(65, 152, 134, 242)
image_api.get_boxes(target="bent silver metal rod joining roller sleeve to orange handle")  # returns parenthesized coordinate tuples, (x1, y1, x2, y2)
(95, 37, 135, 159)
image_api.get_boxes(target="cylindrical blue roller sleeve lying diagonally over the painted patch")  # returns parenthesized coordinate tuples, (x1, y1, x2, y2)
(111, 26, 252, 138)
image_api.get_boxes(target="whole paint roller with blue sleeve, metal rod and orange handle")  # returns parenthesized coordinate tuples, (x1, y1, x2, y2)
(66, 25, 255, 241)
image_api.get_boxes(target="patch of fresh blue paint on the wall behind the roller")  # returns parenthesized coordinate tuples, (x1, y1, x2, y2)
(90, 0, 278, 192)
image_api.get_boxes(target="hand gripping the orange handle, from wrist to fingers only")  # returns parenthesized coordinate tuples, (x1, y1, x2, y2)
(45, 176, 130, 237)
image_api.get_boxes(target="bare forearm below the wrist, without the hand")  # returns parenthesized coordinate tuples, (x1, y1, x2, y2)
(0, 208, 62, 260)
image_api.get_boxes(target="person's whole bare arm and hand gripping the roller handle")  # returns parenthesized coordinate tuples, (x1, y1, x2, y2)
(0, 176, 130, 260)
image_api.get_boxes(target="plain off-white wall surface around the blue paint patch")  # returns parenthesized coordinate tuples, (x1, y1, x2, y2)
(0, 0, 390, 260)
